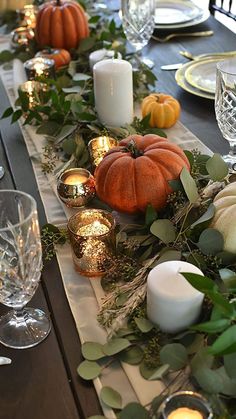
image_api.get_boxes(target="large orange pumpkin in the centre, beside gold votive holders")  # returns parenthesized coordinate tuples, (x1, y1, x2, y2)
(95, 134, 189, 214)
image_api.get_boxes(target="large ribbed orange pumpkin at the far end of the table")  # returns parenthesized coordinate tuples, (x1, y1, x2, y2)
(35, 0, 89, 50)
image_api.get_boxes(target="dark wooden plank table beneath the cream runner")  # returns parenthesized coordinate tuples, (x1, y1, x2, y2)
(0, 13, 236, 419)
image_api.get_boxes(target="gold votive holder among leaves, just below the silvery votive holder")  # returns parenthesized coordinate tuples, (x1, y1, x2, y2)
(19, 80, 48, 109)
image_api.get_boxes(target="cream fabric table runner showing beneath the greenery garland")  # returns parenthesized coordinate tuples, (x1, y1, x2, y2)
(0, 54, 211, 419)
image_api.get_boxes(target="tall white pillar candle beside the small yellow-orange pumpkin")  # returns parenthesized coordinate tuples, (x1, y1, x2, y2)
(93, 59, 133, 127)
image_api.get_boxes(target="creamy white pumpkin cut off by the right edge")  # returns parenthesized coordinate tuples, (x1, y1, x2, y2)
(211, 182, 236, 253)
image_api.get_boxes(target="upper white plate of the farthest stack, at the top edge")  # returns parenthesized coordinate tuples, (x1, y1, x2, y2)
(155, 0, 203, 25)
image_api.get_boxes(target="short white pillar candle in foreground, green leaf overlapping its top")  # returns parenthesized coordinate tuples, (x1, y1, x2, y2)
(147, 261, 204, 333)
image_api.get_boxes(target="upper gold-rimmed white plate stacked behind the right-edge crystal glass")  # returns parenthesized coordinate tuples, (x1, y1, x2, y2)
(185, 57, 224, 94)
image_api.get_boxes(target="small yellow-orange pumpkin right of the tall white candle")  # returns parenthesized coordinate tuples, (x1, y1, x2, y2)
(141, 93, 180, 128)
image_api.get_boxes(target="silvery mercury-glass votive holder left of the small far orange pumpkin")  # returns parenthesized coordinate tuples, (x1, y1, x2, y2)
(24, 57, 55, 80)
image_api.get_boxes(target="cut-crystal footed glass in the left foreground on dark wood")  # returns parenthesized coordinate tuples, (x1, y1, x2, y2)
(0, 190, 51, 349)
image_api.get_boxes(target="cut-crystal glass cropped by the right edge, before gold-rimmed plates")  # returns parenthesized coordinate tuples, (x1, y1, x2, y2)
(215, 58, 236, 172)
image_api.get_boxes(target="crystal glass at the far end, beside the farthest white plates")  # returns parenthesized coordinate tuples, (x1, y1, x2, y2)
(121, 0, 155, 67)
